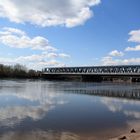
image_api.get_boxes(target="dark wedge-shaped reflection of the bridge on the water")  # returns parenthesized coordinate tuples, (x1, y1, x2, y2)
(66, 84, 140, 100)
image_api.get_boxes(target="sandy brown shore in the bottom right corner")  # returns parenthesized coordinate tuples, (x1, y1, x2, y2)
(109, 131, 140, 140)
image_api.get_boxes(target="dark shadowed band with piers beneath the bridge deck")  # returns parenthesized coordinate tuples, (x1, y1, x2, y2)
(42, 74, 140, 83)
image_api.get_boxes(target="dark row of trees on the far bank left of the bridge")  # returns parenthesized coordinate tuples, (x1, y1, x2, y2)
(0, 64, 41, 78)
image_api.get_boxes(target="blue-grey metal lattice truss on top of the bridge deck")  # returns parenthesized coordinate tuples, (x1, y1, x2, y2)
(44, 65, 140, 75)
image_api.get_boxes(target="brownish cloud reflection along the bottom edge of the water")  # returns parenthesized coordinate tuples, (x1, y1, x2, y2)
(0, 130, 80, 140)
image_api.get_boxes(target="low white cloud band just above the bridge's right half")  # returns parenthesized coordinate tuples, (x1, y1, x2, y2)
(101, 56, 140, 65)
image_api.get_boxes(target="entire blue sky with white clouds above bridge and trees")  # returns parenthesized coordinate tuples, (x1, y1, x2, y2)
(0, 0, 140, 70)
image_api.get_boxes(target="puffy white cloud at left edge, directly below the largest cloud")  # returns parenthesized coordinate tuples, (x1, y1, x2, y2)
(0, 27, 56, 51)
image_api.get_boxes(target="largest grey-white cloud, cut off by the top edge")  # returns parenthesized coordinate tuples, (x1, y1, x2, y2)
(0, 0, 100, 27)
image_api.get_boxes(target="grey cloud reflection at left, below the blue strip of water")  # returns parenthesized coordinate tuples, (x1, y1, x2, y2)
(0, 105, 54, 126)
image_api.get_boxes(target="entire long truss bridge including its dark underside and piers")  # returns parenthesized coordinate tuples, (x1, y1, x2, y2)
(43, 65, 140, 82)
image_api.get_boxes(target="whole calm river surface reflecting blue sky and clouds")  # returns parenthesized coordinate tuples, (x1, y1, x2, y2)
(0, 80, 140, 140)
